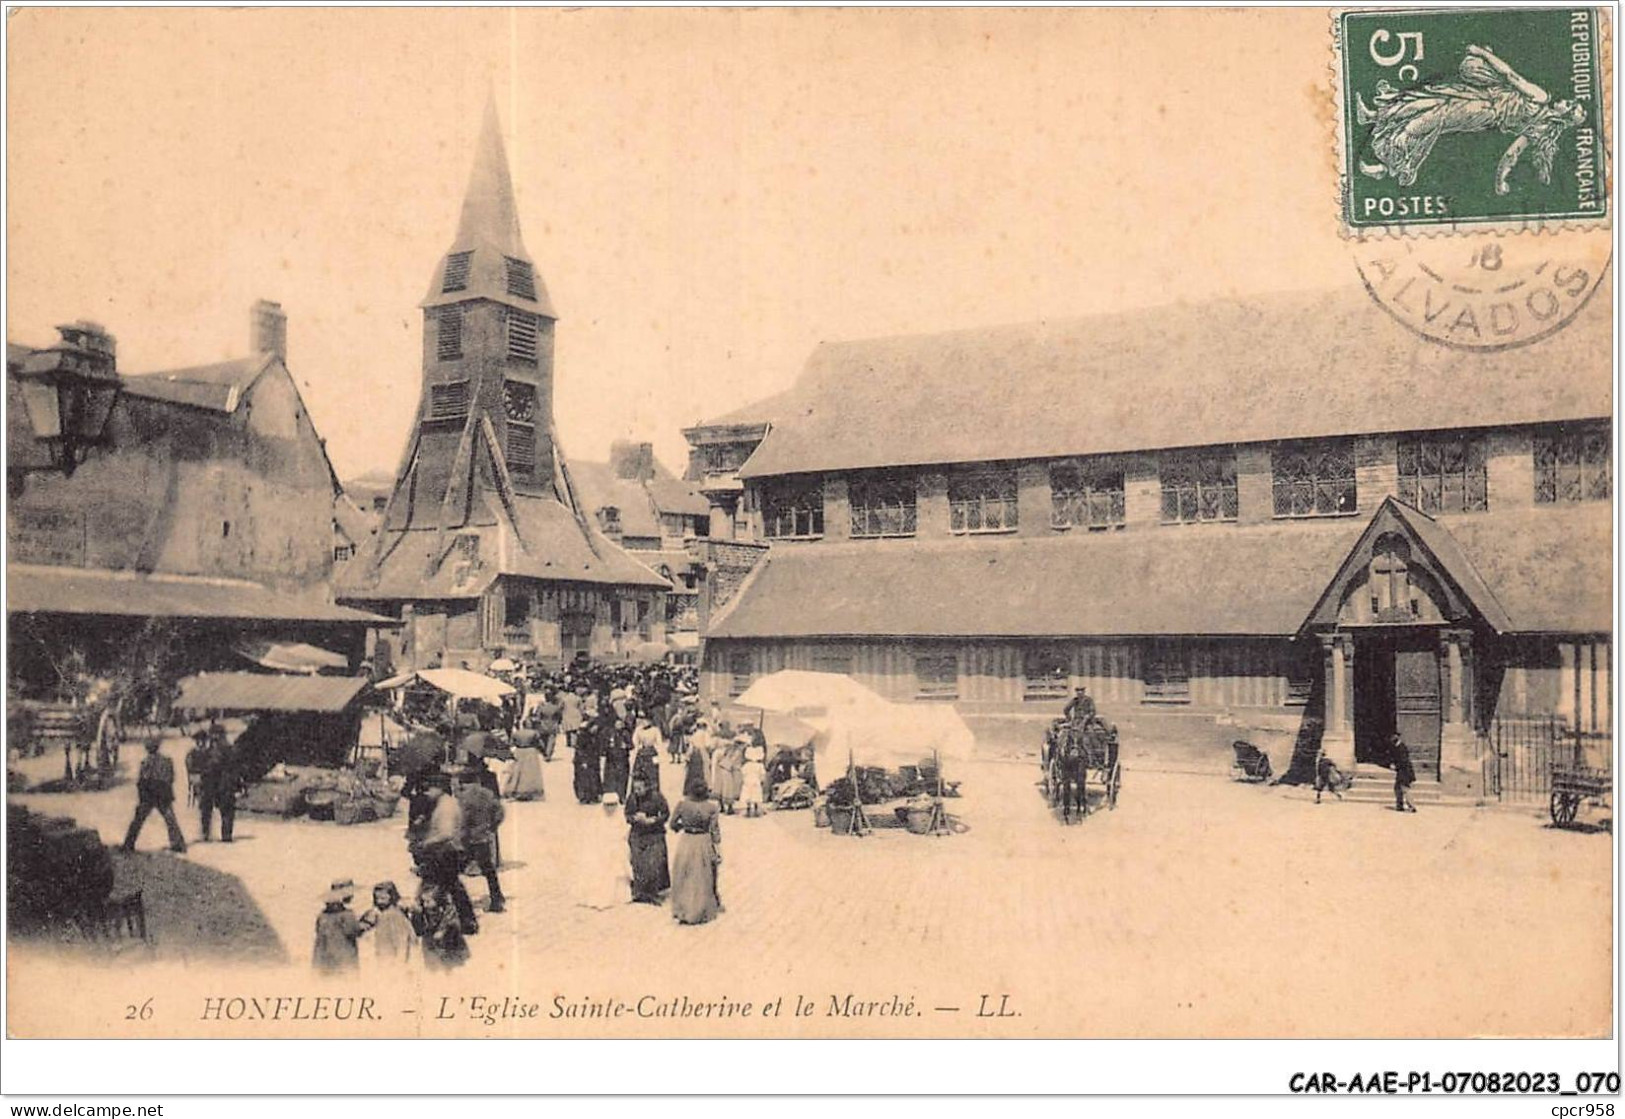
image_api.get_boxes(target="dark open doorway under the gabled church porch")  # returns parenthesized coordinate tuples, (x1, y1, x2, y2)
(1354, 627, 1445, 781)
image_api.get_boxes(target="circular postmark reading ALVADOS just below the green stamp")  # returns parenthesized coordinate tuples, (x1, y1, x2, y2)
(1354, 229, 1612, 349)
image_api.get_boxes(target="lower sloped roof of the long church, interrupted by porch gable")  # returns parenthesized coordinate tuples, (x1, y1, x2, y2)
(707, 508, 1612, 638)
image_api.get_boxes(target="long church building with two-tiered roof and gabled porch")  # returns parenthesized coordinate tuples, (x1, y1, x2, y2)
(687, 289, 1612, 796)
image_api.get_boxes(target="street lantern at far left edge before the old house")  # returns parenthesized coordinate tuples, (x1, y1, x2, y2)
(7, 320, 119, 474)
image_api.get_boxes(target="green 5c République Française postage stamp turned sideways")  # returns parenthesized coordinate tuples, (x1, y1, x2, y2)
(1336, 6, 1609, 231)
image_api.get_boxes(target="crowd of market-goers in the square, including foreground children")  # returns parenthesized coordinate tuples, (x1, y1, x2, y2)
(314, 664, 799, 971)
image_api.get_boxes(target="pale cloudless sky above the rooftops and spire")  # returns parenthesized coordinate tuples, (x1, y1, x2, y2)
(7, 8, 1357, 477)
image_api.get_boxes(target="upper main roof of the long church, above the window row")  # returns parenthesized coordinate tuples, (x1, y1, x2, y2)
(741, 284, 1612, 477)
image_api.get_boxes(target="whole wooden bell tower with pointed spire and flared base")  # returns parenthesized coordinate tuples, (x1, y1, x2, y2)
(338, 104, 671, 671)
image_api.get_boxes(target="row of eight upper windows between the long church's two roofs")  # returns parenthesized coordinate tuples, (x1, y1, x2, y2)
(762, 426, 1612, 538)
